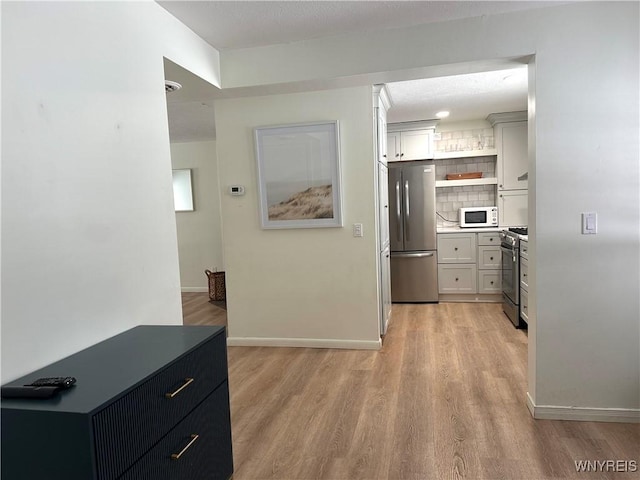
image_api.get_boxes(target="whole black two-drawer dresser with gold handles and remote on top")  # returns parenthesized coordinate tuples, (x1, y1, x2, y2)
(1, 326, 233, 480)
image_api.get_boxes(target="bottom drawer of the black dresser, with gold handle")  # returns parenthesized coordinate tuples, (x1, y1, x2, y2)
(120, 382, 233, 480)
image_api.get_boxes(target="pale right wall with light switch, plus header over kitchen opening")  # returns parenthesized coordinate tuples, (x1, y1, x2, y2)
(219, 2, 640, 418)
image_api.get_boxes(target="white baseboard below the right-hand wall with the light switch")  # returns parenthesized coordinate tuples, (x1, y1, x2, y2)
(527, 392, 640, 423)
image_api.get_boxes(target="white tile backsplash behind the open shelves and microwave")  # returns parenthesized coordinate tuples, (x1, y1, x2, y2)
(435, 155, 496, 227)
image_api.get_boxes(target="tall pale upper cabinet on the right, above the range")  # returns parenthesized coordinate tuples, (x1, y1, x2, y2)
(487, 112, 529, 190)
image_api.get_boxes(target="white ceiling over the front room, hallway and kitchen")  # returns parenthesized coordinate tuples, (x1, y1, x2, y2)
(158, 0, 544, 142)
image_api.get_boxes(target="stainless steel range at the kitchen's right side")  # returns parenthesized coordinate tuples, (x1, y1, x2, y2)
(500, 227, 527, 328)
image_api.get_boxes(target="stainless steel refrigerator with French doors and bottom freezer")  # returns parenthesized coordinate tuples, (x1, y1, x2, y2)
(389, 161, 438, 303)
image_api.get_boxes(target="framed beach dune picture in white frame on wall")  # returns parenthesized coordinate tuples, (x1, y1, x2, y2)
(254, 120, 342, 228)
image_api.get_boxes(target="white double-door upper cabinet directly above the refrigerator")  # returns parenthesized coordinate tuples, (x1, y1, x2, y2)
(387, 120, 437, 162)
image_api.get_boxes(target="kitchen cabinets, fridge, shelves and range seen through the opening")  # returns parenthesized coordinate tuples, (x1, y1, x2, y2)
(374, 69, 528, 333)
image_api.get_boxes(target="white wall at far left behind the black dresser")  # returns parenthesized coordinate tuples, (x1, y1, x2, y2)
(1, 2, 219, 382)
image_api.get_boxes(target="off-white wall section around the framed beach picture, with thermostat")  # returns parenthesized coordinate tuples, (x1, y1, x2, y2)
(215, 86, 380, 348)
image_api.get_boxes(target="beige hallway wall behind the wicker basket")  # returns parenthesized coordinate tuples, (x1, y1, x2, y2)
(171, 142, 224, 292)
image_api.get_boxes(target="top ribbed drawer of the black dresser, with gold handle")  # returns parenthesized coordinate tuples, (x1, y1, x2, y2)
(93, 335, 227, 480)
